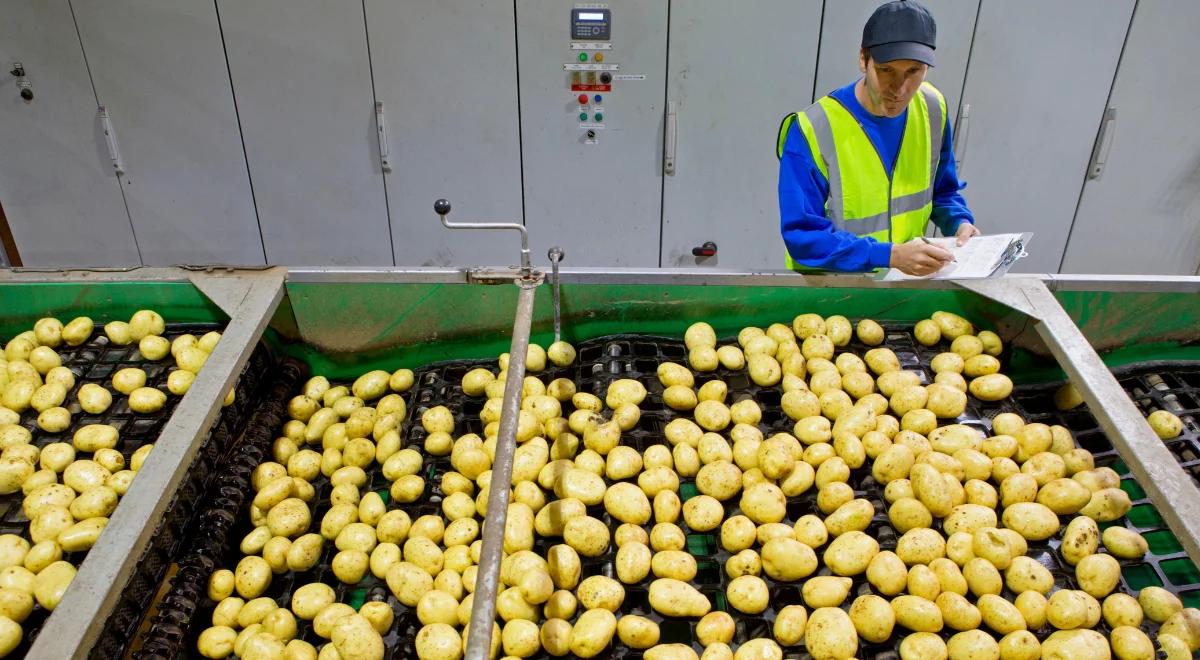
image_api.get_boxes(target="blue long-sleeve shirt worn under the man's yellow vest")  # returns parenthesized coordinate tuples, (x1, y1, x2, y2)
(779, 80, 974, 272)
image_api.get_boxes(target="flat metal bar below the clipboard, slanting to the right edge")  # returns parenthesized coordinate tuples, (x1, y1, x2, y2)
(959, 277, 1200, 562)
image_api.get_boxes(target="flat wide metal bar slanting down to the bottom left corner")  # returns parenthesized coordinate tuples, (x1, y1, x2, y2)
(29, 269, 285, 659)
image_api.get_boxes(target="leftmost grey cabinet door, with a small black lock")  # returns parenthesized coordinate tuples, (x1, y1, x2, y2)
(0, 0, 142, 268)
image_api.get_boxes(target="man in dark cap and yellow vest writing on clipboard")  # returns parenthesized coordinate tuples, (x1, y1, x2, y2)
(776, 0, 979, 275)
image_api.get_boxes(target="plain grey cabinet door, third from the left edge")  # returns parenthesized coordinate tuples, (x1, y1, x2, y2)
(217, 0, 394, 266)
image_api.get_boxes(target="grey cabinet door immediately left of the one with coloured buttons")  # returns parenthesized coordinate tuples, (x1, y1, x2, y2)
(366, 0, 523, 266)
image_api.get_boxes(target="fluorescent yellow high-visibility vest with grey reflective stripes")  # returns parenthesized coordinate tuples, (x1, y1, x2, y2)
(776, 83, 946, 269)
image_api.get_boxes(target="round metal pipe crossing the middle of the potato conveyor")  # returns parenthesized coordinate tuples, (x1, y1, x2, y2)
(466, 277, 541, 660)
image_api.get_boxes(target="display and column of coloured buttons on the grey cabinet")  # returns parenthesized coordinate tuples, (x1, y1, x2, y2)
(563, 2, 620, 144)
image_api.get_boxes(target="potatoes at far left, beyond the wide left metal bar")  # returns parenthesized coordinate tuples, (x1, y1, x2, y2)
(0, 310, 225, 658)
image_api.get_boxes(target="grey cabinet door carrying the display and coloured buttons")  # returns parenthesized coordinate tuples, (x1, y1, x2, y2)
(516, 0, 667, 266)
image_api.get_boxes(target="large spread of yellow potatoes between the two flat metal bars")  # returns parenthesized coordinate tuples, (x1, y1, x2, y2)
(199, 312, 1200, 660)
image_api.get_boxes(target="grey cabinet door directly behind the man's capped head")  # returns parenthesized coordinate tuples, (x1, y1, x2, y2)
(814, 0, 979, 123)
